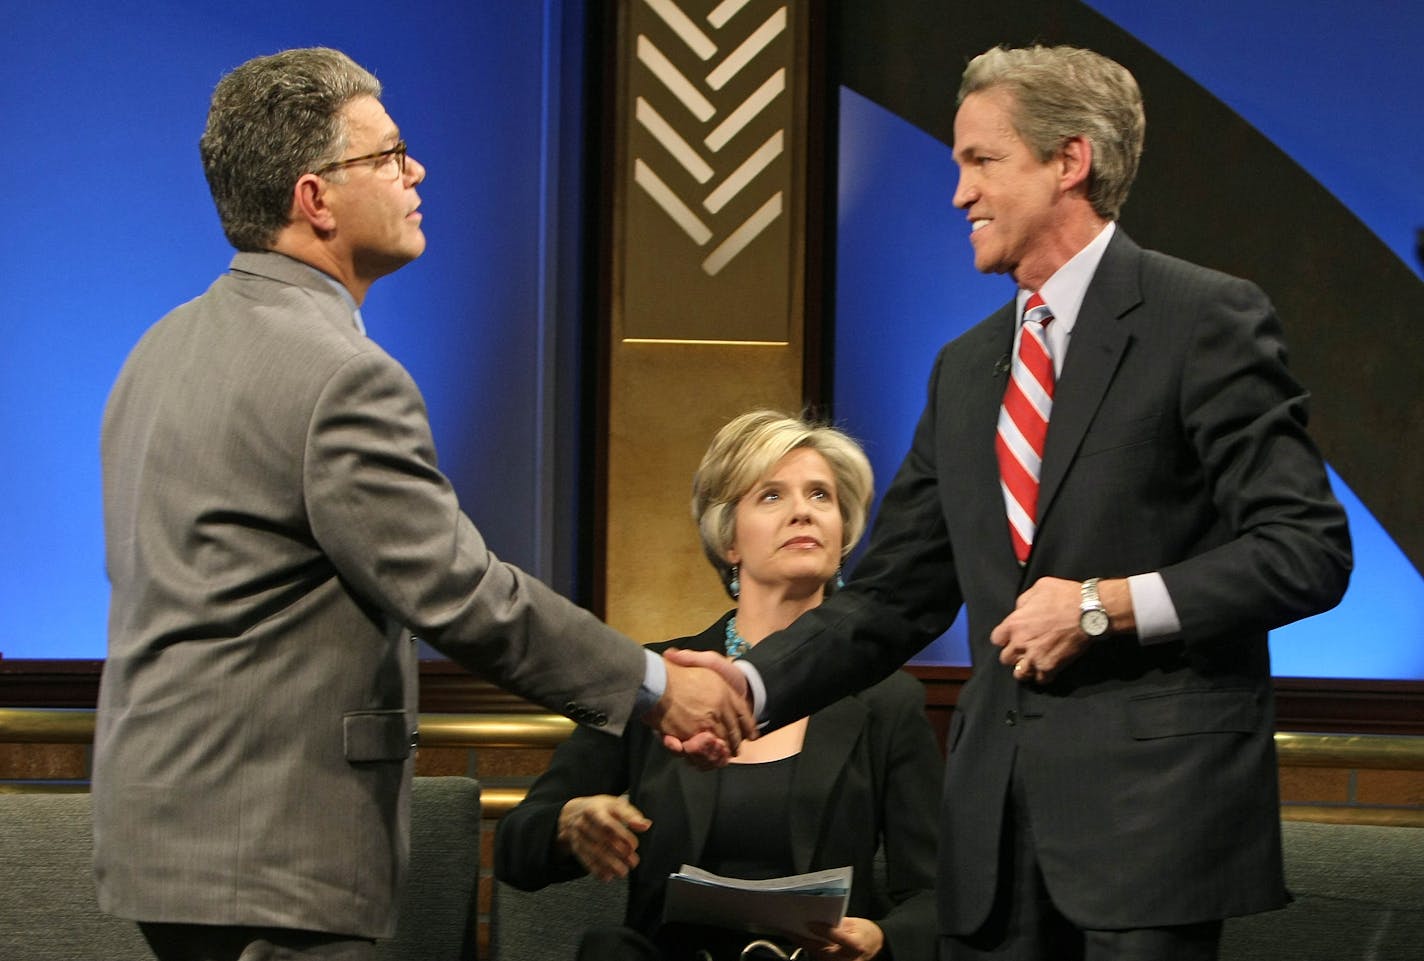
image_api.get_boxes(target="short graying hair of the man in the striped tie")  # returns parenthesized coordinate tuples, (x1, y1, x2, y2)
(957, 47, 1148, 221)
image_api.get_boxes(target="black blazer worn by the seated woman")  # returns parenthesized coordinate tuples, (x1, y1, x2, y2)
(494, 616, 943, 961)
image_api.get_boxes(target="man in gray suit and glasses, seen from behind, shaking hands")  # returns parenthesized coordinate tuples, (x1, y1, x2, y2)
(93, 48, 749, 960)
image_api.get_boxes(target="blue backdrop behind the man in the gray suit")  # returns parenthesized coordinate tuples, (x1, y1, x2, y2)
(0, 0, 578, 658)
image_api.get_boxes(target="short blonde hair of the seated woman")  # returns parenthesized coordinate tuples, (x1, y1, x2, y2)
(692, 410, 874, 592)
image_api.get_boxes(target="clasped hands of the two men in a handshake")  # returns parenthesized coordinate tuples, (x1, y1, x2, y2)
(644, 649, 756, 769)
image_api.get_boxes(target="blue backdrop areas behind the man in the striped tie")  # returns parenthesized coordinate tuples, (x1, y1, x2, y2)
(834, 0, 1424, 678)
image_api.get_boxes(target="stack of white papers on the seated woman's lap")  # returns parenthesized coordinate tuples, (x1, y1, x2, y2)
(664, 864, 852, 940)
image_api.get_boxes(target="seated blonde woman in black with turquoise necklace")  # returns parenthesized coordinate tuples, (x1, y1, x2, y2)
(494, 411, 941, 961)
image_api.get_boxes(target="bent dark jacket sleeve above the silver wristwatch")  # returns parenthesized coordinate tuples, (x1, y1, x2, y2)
(1162, 270, 1351, 638)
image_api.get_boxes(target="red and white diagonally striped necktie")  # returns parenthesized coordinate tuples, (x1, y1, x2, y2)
(994, 293, 1054, 564)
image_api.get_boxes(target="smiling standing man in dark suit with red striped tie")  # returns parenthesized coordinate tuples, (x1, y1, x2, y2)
(672, 47, 1351, 961)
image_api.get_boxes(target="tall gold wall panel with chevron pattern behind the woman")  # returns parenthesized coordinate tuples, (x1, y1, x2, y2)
(602, 0, 807, 642)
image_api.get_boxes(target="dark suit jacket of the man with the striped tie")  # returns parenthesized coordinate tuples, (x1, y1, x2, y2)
(749, 229, 1350, 934)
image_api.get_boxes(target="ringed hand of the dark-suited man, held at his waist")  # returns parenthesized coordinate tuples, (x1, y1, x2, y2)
(988, 577, 1092, 683)
